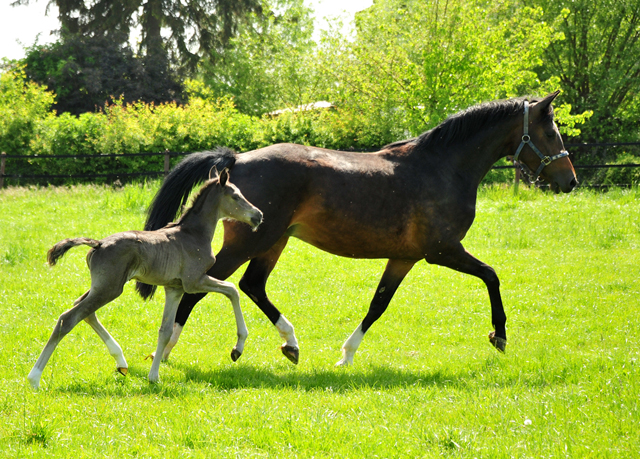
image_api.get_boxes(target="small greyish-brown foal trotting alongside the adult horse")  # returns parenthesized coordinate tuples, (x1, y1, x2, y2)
(28, 169, 262, 389)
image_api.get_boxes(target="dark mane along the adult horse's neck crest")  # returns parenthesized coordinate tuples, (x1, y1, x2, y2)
(383, 97, 553, 150)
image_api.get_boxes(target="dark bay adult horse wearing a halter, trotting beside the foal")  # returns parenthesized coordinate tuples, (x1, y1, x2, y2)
(138, 92, 577, 365)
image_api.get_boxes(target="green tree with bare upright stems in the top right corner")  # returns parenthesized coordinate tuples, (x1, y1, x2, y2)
(528, 0, 640, 141)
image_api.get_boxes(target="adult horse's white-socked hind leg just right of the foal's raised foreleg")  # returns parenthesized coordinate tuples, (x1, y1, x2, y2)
(239, 236, 300, 364)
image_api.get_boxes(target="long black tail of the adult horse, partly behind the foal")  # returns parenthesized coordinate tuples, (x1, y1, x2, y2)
(136, 147, 236, 299)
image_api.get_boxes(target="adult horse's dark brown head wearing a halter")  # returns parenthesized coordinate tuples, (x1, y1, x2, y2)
(514, 91, 578, 193)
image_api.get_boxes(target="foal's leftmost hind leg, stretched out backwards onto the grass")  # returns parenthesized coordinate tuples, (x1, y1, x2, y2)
(27, 285, 122, 389)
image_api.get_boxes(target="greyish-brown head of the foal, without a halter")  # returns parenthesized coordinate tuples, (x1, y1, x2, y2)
(209, 168, 262, 231)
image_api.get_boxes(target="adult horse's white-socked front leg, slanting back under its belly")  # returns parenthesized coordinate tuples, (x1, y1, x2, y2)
(336, 260, 416, 366)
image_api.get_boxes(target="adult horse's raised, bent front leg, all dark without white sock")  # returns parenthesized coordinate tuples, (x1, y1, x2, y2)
(425, 243, 507, 352)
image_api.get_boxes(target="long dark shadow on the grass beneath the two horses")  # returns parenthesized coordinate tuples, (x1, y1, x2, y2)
(52, 356, 568, 398)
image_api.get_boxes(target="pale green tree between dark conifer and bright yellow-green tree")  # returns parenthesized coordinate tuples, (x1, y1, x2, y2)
(199, 0, 324, 115)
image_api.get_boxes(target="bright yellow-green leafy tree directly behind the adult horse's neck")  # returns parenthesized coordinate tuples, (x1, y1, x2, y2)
(321, 0, 580, 136)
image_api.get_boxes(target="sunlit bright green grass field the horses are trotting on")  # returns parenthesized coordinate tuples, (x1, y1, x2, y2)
(0, 183, 640, 458)
